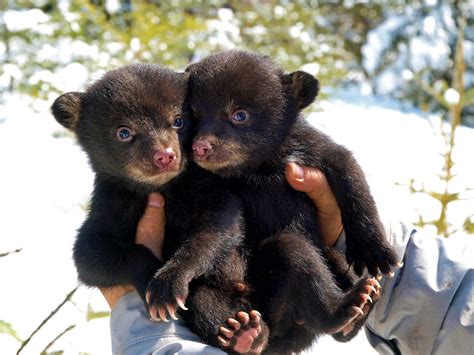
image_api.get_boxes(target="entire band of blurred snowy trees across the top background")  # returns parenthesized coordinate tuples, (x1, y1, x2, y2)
(0, 0, 474, 124)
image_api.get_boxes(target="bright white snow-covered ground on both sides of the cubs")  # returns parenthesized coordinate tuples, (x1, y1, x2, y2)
(0, 90, 474, 354)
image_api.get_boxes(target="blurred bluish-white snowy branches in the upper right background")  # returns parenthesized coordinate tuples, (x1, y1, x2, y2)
(361, 3, 462, 95)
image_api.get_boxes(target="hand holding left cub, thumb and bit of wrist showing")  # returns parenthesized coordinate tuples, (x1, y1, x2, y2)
(100, 193, 166, 309)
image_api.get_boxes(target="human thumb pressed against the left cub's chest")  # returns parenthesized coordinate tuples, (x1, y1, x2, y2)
(135, 193, 166, 260)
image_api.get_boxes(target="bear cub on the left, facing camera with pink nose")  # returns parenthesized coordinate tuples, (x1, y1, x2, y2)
(52, 64, 268, 353)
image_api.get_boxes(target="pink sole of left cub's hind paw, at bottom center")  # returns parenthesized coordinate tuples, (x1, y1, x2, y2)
(217, 310, 262, 354)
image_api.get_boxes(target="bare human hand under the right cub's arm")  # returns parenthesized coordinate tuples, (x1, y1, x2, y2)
(285, 163, 343, 245)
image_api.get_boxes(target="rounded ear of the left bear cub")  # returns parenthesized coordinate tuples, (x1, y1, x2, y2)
(51, 92, 84, 131)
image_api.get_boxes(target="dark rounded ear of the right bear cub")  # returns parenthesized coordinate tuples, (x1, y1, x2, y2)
(282, 71, 319, 109)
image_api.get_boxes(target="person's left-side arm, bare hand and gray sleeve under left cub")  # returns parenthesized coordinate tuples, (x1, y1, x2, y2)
(101, 194, 224, 355)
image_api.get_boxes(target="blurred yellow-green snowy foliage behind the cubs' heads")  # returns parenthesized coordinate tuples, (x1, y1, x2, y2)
(0, 0, 404, 97)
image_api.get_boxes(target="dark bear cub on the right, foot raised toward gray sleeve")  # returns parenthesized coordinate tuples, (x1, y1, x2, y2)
(187, 51, 397, 353)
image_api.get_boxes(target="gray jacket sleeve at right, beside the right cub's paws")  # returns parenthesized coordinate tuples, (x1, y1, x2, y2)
(366, 224, 474, 355)
